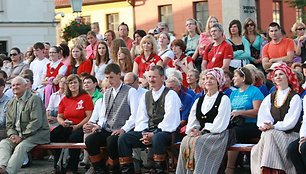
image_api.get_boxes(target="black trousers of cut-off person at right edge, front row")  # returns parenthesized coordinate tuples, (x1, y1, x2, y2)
(288, 139, 306, 174)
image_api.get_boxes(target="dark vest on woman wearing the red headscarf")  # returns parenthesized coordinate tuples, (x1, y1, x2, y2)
(270, 90, 301, 133)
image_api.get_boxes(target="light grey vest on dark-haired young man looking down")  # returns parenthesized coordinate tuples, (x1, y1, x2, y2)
(104, 84, 131, 132)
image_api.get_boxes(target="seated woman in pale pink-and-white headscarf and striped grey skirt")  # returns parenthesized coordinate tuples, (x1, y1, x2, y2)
(176, 68, 231, 174)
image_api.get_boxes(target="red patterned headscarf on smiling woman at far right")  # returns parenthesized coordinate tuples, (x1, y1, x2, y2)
(272, 64, 300, 93)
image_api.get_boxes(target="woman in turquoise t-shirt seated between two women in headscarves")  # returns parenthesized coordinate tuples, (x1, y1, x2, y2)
(226, 67, 264, 174)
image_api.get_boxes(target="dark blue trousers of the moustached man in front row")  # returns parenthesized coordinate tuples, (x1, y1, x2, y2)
(118, 131, 172, 157)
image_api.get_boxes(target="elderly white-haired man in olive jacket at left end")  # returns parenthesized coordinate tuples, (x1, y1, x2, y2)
(0, 76, 50, 174)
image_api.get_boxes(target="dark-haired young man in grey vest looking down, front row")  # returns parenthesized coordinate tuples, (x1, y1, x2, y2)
(83, 64, 138, 174)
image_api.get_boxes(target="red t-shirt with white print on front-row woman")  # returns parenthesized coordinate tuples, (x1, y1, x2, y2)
(58, 94, 94, 124)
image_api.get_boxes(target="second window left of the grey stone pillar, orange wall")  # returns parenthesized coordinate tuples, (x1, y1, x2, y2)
(158, 5, 173, 32)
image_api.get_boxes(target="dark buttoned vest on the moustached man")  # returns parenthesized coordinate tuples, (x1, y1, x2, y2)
(145, 88, 169, 131)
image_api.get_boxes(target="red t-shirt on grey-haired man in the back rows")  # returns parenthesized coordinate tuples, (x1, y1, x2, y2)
(203, 40, 234, 69)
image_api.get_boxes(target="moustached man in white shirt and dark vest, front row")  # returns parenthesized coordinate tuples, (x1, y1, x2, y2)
(118, 65, 181, 174)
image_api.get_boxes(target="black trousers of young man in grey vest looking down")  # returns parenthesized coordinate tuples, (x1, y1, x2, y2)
(85, 129, 119, 160)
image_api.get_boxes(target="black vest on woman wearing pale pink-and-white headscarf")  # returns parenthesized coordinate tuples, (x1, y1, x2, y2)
(196, 92, 224, 130)
